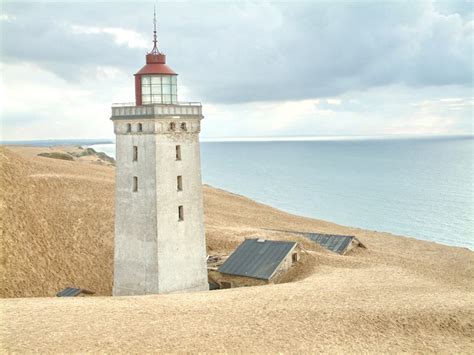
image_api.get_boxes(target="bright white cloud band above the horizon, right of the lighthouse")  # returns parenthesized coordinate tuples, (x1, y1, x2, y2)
(203, 85, 474, 137)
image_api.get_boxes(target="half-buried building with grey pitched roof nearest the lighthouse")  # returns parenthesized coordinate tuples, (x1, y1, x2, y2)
(209, 239, 299, 288)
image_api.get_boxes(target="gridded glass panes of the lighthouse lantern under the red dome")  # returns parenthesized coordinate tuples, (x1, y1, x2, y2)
(142, 75, 178, 105)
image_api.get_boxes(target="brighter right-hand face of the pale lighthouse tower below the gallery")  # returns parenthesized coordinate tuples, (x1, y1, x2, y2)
(156, 130, 208, 292)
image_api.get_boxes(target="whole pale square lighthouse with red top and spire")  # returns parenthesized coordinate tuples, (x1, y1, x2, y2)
(111, 16, 208, 296)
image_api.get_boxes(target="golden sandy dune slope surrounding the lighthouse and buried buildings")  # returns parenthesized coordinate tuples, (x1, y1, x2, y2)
(0, 148, 474, 353)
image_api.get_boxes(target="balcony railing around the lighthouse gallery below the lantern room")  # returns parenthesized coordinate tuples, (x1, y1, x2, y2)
(112, 102, 202, 118)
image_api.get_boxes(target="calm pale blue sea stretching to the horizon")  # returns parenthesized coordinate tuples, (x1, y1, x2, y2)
(72, 137, 474, 250)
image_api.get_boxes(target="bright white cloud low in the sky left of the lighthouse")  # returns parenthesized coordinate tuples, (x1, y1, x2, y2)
(0, 63, 126, 140)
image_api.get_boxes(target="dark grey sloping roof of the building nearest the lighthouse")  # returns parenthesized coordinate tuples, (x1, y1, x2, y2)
(218, 239, 297, 280)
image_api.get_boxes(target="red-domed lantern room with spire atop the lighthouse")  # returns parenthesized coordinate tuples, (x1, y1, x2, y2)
(135, 11, 178, 106)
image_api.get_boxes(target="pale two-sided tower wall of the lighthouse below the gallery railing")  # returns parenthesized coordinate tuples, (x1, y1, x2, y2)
(113, 116, 208, 295)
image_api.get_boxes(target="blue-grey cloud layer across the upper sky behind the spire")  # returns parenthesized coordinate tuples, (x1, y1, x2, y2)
(1, 2, 474, 103)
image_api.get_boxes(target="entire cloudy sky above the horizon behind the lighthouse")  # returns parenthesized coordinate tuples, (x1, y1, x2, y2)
(0, 0, 474, 140)
